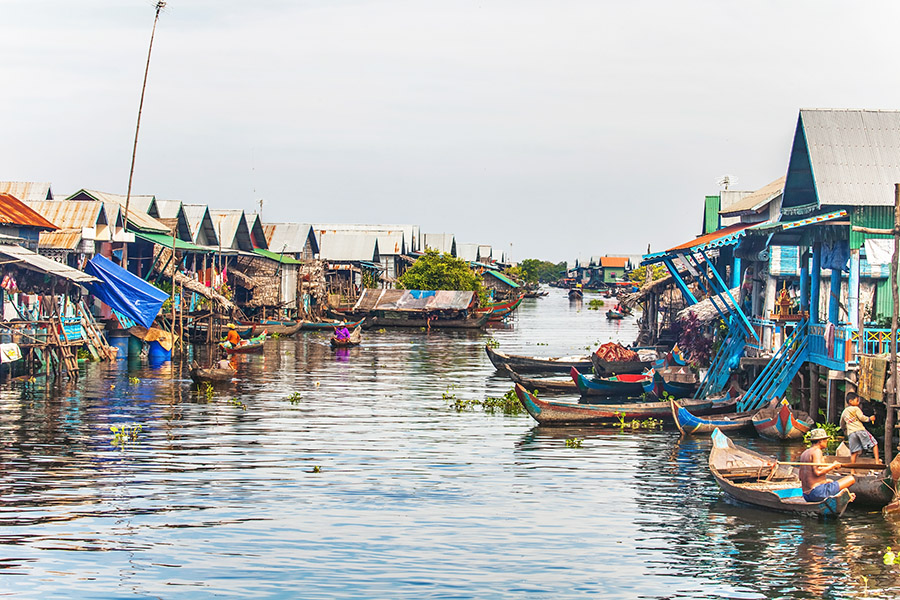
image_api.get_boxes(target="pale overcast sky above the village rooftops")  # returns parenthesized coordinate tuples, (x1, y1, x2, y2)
(0, 0, 900, 262)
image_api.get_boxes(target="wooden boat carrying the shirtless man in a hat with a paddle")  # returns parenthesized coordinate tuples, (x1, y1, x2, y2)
(709, 429, 850, 517)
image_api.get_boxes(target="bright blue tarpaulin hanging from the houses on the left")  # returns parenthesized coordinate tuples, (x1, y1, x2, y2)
(84, 254, 169, 328)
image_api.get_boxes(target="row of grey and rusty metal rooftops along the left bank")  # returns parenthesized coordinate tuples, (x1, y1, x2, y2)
(0, 182, 505, 264)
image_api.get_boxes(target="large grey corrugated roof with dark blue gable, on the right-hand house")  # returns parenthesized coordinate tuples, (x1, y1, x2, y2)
(783, 109, 900, 212)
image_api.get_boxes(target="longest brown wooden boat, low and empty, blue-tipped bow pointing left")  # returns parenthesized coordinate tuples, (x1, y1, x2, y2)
(515, 383, 713, 425)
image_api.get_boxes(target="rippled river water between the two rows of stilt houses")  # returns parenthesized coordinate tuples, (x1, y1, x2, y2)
(0, 290, 900, 599)
